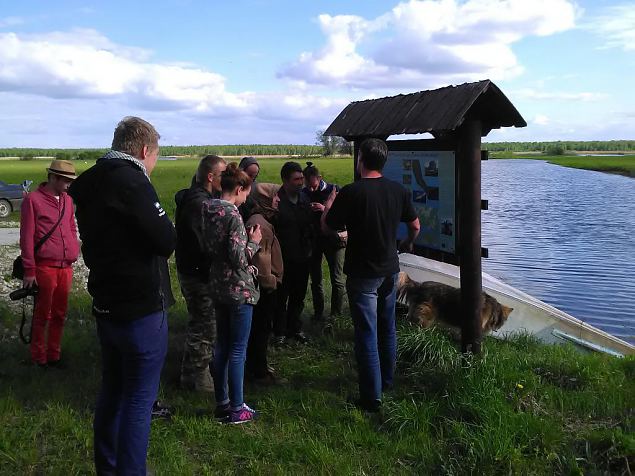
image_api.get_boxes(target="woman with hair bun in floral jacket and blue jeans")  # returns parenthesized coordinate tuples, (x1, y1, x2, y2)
(203, 163, 262, 424)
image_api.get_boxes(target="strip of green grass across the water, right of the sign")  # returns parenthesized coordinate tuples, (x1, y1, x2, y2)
(492, 152, 635, 177)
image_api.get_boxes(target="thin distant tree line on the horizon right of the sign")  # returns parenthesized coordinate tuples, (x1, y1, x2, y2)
(483, 140, 635, 155)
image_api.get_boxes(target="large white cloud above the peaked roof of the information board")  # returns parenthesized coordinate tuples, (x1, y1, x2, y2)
(279, 0, 580, 88)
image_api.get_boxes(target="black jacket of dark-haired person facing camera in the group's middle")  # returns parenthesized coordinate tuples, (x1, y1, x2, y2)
(272, 188, 315, 266)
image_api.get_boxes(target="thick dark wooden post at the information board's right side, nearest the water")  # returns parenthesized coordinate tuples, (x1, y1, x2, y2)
(457, 120, 483, 354)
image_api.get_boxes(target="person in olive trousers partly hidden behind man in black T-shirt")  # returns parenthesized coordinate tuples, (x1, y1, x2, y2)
(302, 162, 346, 329)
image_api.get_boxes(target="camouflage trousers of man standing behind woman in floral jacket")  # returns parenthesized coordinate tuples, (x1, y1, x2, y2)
(179, 273, 216, 378)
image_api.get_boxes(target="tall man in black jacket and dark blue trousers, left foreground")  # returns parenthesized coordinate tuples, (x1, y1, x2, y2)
(69, 117, 176, 475)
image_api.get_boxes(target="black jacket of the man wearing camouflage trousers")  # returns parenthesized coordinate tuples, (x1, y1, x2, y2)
(174, 183, 214, 281)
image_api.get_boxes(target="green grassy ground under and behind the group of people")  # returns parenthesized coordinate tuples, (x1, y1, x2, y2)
(0, 159, 635, 475)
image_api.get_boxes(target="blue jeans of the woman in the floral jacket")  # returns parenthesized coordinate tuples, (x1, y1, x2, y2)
(214, 303, 254, 408)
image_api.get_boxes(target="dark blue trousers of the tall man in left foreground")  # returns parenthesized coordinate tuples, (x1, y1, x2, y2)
(93, 311, 168, 475)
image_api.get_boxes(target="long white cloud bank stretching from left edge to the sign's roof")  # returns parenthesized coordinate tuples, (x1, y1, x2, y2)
(0, 29, 348, 124)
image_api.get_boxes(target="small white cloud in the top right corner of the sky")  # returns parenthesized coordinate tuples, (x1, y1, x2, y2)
(585, 2, 635, 51)
